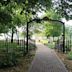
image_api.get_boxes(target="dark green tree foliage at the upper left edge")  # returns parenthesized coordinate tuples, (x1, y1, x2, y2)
(0, 7, 12, 33)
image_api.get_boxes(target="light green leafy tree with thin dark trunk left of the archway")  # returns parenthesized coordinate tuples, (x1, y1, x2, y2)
(5, 1, 25, 43)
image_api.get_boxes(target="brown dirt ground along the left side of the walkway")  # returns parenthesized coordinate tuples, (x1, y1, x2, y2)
(0, 50, 35, 72)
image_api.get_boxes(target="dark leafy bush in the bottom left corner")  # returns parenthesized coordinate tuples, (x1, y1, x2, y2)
(0, 52, 18, 68)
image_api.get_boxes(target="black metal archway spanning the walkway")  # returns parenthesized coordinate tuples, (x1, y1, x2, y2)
(26, 17, 65, 53)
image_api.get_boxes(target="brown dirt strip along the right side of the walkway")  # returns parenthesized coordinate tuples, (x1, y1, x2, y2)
(56, 51, 72, 72)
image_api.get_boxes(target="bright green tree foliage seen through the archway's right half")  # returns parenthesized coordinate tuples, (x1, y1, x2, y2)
(44, 22, 62, 37)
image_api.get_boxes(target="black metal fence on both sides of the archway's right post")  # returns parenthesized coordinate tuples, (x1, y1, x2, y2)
(55, 39, 72, 53)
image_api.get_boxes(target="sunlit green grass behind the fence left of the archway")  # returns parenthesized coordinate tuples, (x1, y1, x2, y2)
(0, 41, 26, 54)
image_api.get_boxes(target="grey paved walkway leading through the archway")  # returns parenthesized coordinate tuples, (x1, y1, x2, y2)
(29, 44, 68, 72)
